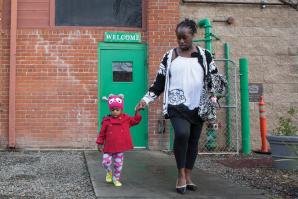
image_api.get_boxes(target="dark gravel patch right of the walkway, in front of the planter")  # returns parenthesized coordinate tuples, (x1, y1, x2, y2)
(195, 154, 298, 199)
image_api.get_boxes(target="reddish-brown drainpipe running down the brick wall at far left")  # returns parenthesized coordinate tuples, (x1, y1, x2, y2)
(8, 0, 18, 148)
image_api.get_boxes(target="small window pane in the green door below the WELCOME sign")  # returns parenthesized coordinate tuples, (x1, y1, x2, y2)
(112, 62, 132, 82)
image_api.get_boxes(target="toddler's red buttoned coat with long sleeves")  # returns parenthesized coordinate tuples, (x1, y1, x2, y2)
(96, 113, 142, 153)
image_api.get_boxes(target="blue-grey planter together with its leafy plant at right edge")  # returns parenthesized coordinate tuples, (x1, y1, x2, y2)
(267, 107, 298, 170)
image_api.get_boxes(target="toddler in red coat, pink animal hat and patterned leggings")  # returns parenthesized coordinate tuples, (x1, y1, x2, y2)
(96, 94, 142, 187)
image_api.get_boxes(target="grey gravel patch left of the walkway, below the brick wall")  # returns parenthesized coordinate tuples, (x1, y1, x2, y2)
(0, 151, 96, 199)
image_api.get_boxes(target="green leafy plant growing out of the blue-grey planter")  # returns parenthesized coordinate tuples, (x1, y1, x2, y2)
(273, 107, 298, 136)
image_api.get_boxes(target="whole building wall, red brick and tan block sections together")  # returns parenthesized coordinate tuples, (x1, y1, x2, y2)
(0, 0, 298, 149)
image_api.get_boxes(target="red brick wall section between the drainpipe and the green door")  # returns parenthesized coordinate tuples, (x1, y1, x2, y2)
(16, 30, 102, 148)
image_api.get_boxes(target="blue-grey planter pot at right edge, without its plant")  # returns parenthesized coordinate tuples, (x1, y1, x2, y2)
(267, 135, 298, 170)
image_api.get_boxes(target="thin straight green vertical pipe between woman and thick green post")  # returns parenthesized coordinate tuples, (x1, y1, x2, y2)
(224, 43, 232, 148)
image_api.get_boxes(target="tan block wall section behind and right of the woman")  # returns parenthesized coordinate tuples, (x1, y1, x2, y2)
(180, 3, 298, 149)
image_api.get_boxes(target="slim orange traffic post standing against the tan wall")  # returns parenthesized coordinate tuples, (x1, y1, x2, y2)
(259, 96, 268, 153)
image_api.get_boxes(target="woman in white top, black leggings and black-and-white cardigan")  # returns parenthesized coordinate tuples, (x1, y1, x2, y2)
(137, 19, 217, 194)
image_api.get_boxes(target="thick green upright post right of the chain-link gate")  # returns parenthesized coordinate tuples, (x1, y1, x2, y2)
(239, 58, 251, 155)
